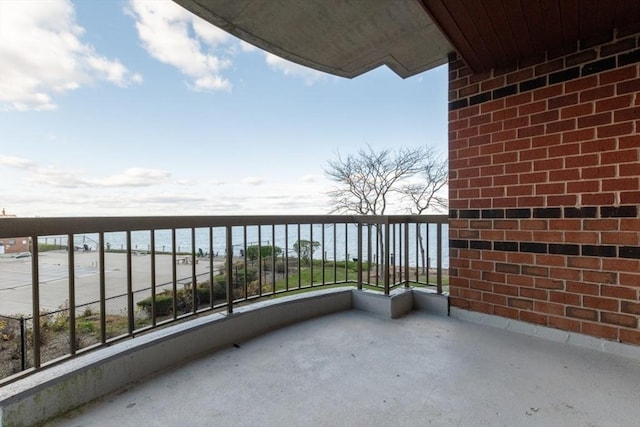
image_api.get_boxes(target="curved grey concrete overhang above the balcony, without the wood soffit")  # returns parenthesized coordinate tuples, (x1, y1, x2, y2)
(174, 0, 453, 78)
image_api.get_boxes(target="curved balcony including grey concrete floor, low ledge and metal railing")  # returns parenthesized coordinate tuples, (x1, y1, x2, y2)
(0, 216, 640, 425)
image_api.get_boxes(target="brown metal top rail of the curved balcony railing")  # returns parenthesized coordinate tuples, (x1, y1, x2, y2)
(0, 215, 448, 238)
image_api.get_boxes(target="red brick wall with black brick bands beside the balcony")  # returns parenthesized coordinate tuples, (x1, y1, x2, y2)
(449, 29, 640, 345)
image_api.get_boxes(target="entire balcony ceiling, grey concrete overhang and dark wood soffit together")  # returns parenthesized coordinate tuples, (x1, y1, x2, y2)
(174, 0, 640, 78)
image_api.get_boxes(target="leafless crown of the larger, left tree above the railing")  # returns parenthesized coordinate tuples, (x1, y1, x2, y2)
(325, 145, 429, 215)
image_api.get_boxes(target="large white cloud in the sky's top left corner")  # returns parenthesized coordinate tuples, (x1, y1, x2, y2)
(0, 0, 142, 111)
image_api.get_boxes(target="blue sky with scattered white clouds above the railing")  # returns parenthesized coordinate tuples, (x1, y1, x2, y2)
(0, 0, 447, 217)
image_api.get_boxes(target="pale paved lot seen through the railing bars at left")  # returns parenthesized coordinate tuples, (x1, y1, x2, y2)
(0, 251, 224, 315)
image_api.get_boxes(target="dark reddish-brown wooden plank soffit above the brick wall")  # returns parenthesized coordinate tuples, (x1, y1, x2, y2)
(421, 0, 640, 72)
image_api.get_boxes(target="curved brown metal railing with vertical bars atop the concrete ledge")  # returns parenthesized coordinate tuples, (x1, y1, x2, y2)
(0, 215, 448, 384)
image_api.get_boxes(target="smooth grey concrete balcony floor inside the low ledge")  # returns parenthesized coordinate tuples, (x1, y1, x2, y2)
(47, 310, 640, 427)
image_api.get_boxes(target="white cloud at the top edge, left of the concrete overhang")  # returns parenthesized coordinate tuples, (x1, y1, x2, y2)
(128, 0, 233, 91)
